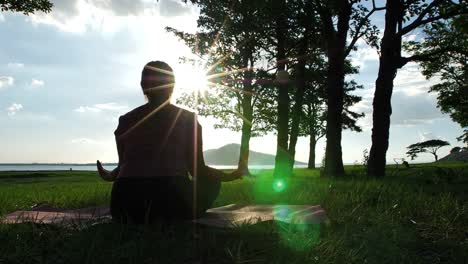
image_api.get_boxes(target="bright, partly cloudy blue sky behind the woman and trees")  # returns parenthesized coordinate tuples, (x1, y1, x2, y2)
(0, 0, 462, 163)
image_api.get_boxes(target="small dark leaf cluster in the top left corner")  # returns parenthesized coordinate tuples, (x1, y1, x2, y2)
(0, 0, 53, 15)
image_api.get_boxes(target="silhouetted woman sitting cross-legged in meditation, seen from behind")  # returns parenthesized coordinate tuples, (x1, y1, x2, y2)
(97, 61, 242, 224)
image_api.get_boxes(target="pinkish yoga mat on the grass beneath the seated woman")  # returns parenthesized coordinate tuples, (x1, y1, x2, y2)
(1, 204, 326, 228)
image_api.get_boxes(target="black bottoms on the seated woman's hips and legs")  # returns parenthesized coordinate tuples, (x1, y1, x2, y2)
(110, 177, 221, 224)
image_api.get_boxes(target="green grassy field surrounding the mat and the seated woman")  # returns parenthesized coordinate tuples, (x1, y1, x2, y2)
(0, 163, 468, 263)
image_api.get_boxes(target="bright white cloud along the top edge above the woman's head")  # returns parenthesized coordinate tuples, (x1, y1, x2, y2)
(27, 0, 197, 34)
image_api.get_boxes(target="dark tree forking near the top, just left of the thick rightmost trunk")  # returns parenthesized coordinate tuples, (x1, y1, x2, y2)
(315, 0, 384, 176)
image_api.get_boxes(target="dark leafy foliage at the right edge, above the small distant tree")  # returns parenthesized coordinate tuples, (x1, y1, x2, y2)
(407, 15, 468, 140)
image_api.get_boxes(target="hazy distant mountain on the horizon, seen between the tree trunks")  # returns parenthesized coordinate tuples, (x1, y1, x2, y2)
(203, 144, 307, 166)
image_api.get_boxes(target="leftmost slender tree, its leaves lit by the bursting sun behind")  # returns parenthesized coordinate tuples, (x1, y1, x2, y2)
(168, 0, 272, 172)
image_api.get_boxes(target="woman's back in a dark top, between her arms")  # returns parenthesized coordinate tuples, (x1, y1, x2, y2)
(115, 104, 196, 178)
